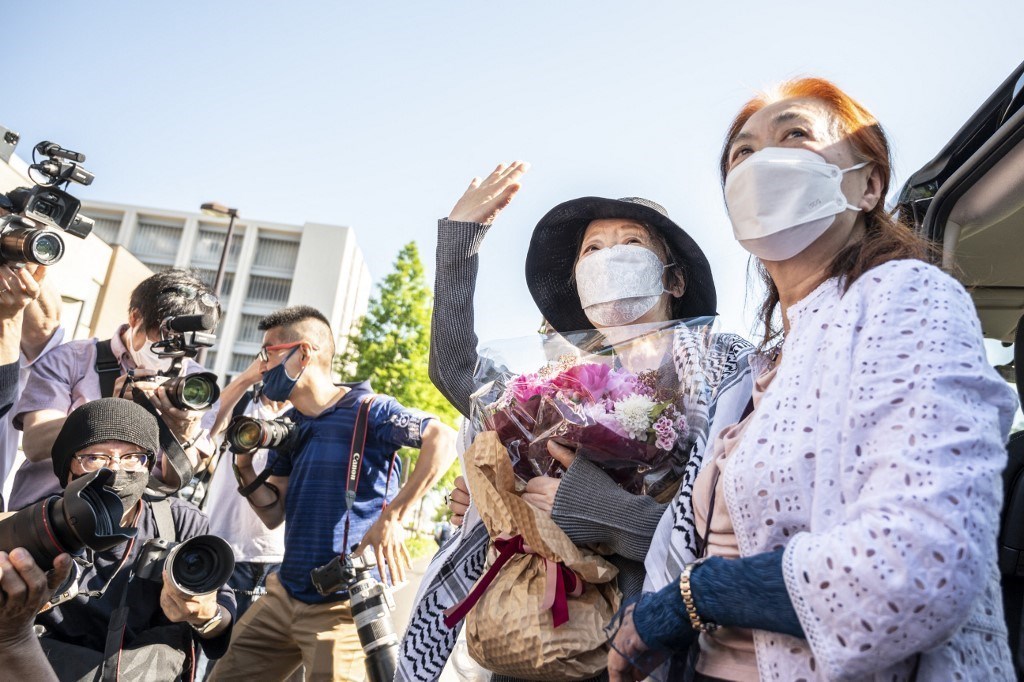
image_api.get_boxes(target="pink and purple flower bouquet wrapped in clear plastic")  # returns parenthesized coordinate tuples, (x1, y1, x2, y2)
(472, 317, 721, 498)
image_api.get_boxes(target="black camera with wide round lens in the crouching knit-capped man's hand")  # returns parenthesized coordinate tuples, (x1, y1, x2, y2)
(135, 536, 234, 596)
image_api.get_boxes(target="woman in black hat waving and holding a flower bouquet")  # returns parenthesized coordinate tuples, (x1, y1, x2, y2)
(397, 162, 751, 680)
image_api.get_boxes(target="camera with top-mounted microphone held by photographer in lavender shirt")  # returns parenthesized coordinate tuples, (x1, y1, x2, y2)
(125, 313, 220, 410)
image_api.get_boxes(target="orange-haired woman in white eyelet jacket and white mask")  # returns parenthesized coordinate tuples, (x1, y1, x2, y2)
(609, 79, 1016, 680)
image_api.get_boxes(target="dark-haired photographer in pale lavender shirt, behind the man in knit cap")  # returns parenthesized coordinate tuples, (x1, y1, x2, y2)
(9, 269, 220, 509)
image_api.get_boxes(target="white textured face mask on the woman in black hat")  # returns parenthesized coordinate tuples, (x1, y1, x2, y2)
(575, 244, 668, 327)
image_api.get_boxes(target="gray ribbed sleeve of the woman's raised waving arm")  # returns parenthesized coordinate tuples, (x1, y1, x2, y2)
(428, 218, 489, 417)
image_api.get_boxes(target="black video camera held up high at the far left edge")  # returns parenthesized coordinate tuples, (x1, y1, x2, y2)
(0, 127, 95, 265)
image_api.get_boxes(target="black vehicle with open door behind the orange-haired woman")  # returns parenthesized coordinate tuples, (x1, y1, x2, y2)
(897, 58, 1024, 679)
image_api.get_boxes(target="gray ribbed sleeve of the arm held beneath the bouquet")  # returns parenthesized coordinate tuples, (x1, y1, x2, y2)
(551, 457, 668, 561)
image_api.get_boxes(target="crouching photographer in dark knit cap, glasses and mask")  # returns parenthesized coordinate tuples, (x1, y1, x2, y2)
(31, 398, 234, 680)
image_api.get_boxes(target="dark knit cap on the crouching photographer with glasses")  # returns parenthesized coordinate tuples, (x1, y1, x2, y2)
(50, 398, 160, 485)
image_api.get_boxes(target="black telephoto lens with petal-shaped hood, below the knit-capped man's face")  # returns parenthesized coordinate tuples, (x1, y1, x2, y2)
(0, 469, 136, 570)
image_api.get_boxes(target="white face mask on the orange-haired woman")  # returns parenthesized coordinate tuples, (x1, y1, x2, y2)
(725, 146, 867, 260)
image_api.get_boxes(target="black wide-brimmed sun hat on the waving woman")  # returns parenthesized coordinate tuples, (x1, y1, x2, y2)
(526, 197, 718, 333)
